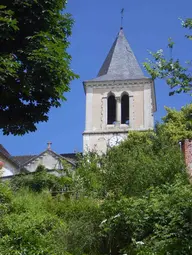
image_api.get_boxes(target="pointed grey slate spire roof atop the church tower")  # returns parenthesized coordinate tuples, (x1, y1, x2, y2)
(91, 28, 146, 81)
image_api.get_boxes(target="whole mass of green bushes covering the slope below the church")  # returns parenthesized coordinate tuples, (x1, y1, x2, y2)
(0, 105, 192, 255)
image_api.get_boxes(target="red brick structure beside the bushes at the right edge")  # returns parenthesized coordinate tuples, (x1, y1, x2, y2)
(182, 139, 192, 177)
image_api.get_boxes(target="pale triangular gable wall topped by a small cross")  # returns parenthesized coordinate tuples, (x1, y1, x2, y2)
(25, 152, 62, 172)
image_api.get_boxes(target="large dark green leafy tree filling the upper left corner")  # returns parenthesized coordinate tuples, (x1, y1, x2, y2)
(0, 0, 77, 135)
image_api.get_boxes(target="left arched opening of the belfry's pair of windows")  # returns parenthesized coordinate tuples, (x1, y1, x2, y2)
(107, 94, 116, 125)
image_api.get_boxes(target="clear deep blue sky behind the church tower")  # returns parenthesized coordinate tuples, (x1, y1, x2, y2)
(0, 0, 192, 155)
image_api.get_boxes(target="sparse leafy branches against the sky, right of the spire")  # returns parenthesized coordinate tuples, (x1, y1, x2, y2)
(144, 18, 192, 95)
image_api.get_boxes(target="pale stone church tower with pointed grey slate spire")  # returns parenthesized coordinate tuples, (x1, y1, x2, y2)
(83, 28, 156, 153)
